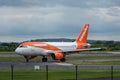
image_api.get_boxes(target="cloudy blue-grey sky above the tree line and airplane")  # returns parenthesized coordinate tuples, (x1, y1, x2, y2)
(0, 0, 120, 42)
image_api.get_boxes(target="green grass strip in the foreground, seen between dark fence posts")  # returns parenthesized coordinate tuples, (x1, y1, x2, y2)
(0, 70, 120, 80)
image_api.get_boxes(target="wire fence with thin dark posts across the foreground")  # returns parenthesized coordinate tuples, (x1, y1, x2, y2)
(0, 65, 120, 80)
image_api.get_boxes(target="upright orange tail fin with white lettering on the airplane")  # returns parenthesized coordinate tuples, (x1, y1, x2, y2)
(76, 24, 90, 43)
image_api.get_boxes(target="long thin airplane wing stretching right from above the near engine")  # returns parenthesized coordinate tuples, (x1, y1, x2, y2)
(59, 48, 102, 54)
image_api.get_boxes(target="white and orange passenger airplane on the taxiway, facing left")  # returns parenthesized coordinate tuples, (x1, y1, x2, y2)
(15, 24, 101, 62)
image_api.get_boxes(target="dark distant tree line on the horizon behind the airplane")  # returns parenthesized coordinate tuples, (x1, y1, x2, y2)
(0, 38, 120, 51)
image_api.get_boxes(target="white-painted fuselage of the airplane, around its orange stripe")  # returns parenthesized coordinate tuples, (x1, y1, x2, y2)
(15, 42, 77, 56)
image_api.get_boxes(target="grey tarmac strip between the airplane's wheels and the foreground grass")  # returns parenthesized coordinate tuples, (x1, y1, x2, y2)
(0, 62, 120, 70)
